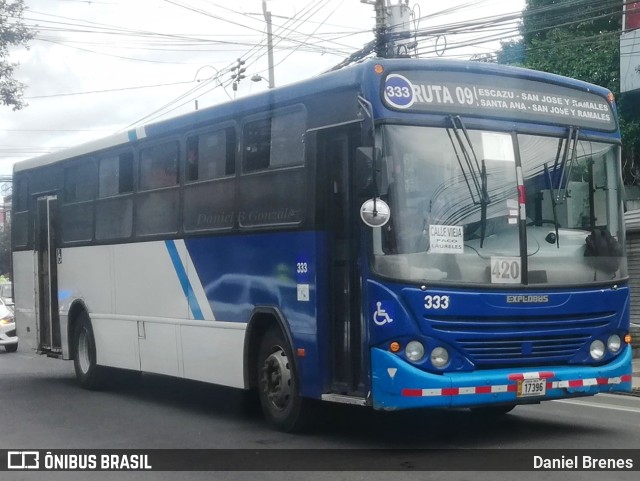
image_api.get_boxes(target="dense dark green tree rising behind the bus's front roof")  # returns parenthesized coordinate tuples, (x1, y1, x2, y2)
(497, 0, 640, 183)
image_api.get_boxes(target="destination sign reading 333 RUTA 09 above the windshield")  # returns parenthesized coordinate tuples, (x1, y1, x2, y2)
(382, 71, 617, 132)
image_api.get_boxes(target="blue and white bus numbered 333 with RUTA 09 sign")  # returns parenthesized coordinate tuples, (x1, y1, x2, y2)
(12, 59, 631, 431)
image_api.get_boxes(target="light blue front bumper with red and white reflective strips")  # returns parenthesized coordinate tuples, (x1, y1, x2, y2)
(371, 346, 631, 410)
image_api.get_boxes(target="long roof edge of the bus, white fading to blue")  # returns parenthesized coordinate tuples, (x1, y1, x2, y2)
(14, 58, 610, 172)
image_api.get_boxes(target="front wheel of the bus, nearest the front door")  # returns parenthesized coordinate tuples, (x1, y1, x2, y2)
(257, 326, 311, 433)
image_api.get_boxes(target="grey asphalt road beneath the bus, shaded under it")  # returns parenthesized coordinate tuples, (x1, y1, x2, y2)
(0, 347, 640, 481)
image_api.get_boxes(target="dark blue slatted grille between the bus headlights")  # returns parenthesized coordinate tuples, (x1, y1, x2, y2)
(427, 312, 615, 369)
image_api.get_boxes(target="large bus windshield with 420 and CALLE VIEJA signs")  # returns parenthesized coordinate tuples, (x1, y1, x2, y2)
(373, 121, 627, 285)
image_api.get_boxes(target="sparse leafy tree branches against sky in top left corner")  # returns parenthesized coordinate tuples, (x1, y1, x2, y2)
(0, 0, 35, 110)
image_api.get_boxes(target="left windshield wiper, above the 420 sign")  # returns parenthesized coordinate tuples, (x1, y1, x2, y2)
(447, 115, 491, 248)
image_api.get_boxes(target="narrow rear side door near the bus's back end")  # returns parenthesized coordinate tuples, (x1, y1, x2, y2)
(35, 196, 62, 354)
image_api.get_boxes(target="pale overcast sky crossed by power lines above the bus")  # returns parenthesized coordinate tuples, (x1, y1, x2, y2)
(0, 0, 524, 195)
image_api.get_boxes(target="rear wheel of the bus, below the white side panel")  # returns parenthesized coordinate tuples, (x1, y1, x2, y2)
(73, 311, 105, 390)
